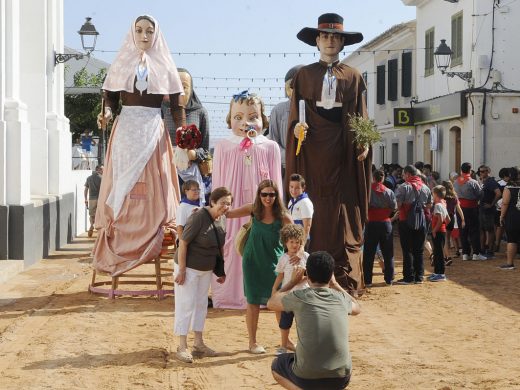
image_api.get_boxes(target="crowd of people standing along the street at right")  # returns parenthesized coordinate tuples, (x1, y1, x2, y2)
(370, 161, 520, 286)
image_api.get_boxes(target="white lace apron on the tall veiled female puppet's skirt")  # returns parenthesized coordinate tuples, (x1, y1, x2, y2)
(107, 106, 162, 219)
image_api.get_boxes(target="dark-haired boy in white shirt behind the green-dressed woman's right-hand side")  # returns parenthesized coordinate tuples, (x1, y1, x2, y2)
(287, 173, 314, 244)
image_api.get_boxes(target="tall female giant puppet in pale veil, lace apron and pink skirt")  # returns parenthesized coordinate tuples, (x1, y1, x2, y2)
(93, 16, 185, 276)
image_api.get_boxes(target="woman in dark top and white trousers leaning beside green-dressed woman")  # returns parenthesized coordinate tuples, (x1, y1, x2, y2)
(174, 187, 232, 363)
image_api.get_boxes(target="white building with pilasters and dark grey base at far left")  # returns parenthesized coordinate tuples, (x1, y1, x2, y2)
(0, 0, 88, 269)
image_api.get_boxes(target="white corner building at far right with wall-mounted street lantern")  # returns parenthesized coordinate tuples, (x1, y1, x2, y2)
(403, 0, 520, 178)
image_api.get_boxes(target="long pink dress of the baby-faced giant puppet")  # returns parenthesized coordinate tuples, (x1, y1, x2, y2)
(211, 135, 283, 309)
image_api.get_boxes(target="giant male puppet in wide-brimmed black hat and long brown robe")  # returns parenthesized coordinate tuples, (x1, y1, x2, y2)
(285, 14, 371, 294)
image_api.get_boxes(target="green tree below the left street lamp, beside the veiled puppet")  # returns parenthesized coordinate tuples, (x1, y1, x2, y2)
(65, 68, 106, 140)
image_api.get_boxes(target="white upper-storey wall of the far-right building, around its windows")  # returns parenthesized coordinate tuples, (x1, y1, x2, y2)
(410, 0, 520, 101)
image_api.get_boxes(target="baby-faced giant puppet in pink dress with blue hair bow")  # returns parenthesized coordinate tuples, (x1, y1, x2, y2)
(211, 91, 282, 309)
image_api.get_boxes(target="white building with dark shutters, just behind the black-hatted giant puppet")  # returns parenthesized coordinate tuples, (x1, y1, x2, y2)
(343, 20, 417, 167)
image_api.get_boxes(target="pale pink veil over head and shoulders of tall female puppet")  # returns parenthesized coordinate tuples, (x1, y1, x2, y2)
(103, 15, 184, 95)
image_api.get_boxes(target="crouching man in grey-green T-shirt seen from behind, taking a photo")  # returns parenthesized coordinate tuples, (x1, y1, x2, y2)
(267, 252, 361, 389)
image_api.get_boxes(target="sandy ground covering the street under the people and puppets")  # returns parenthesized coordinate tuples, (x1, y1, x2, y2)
(0, 233, 520, 390)
